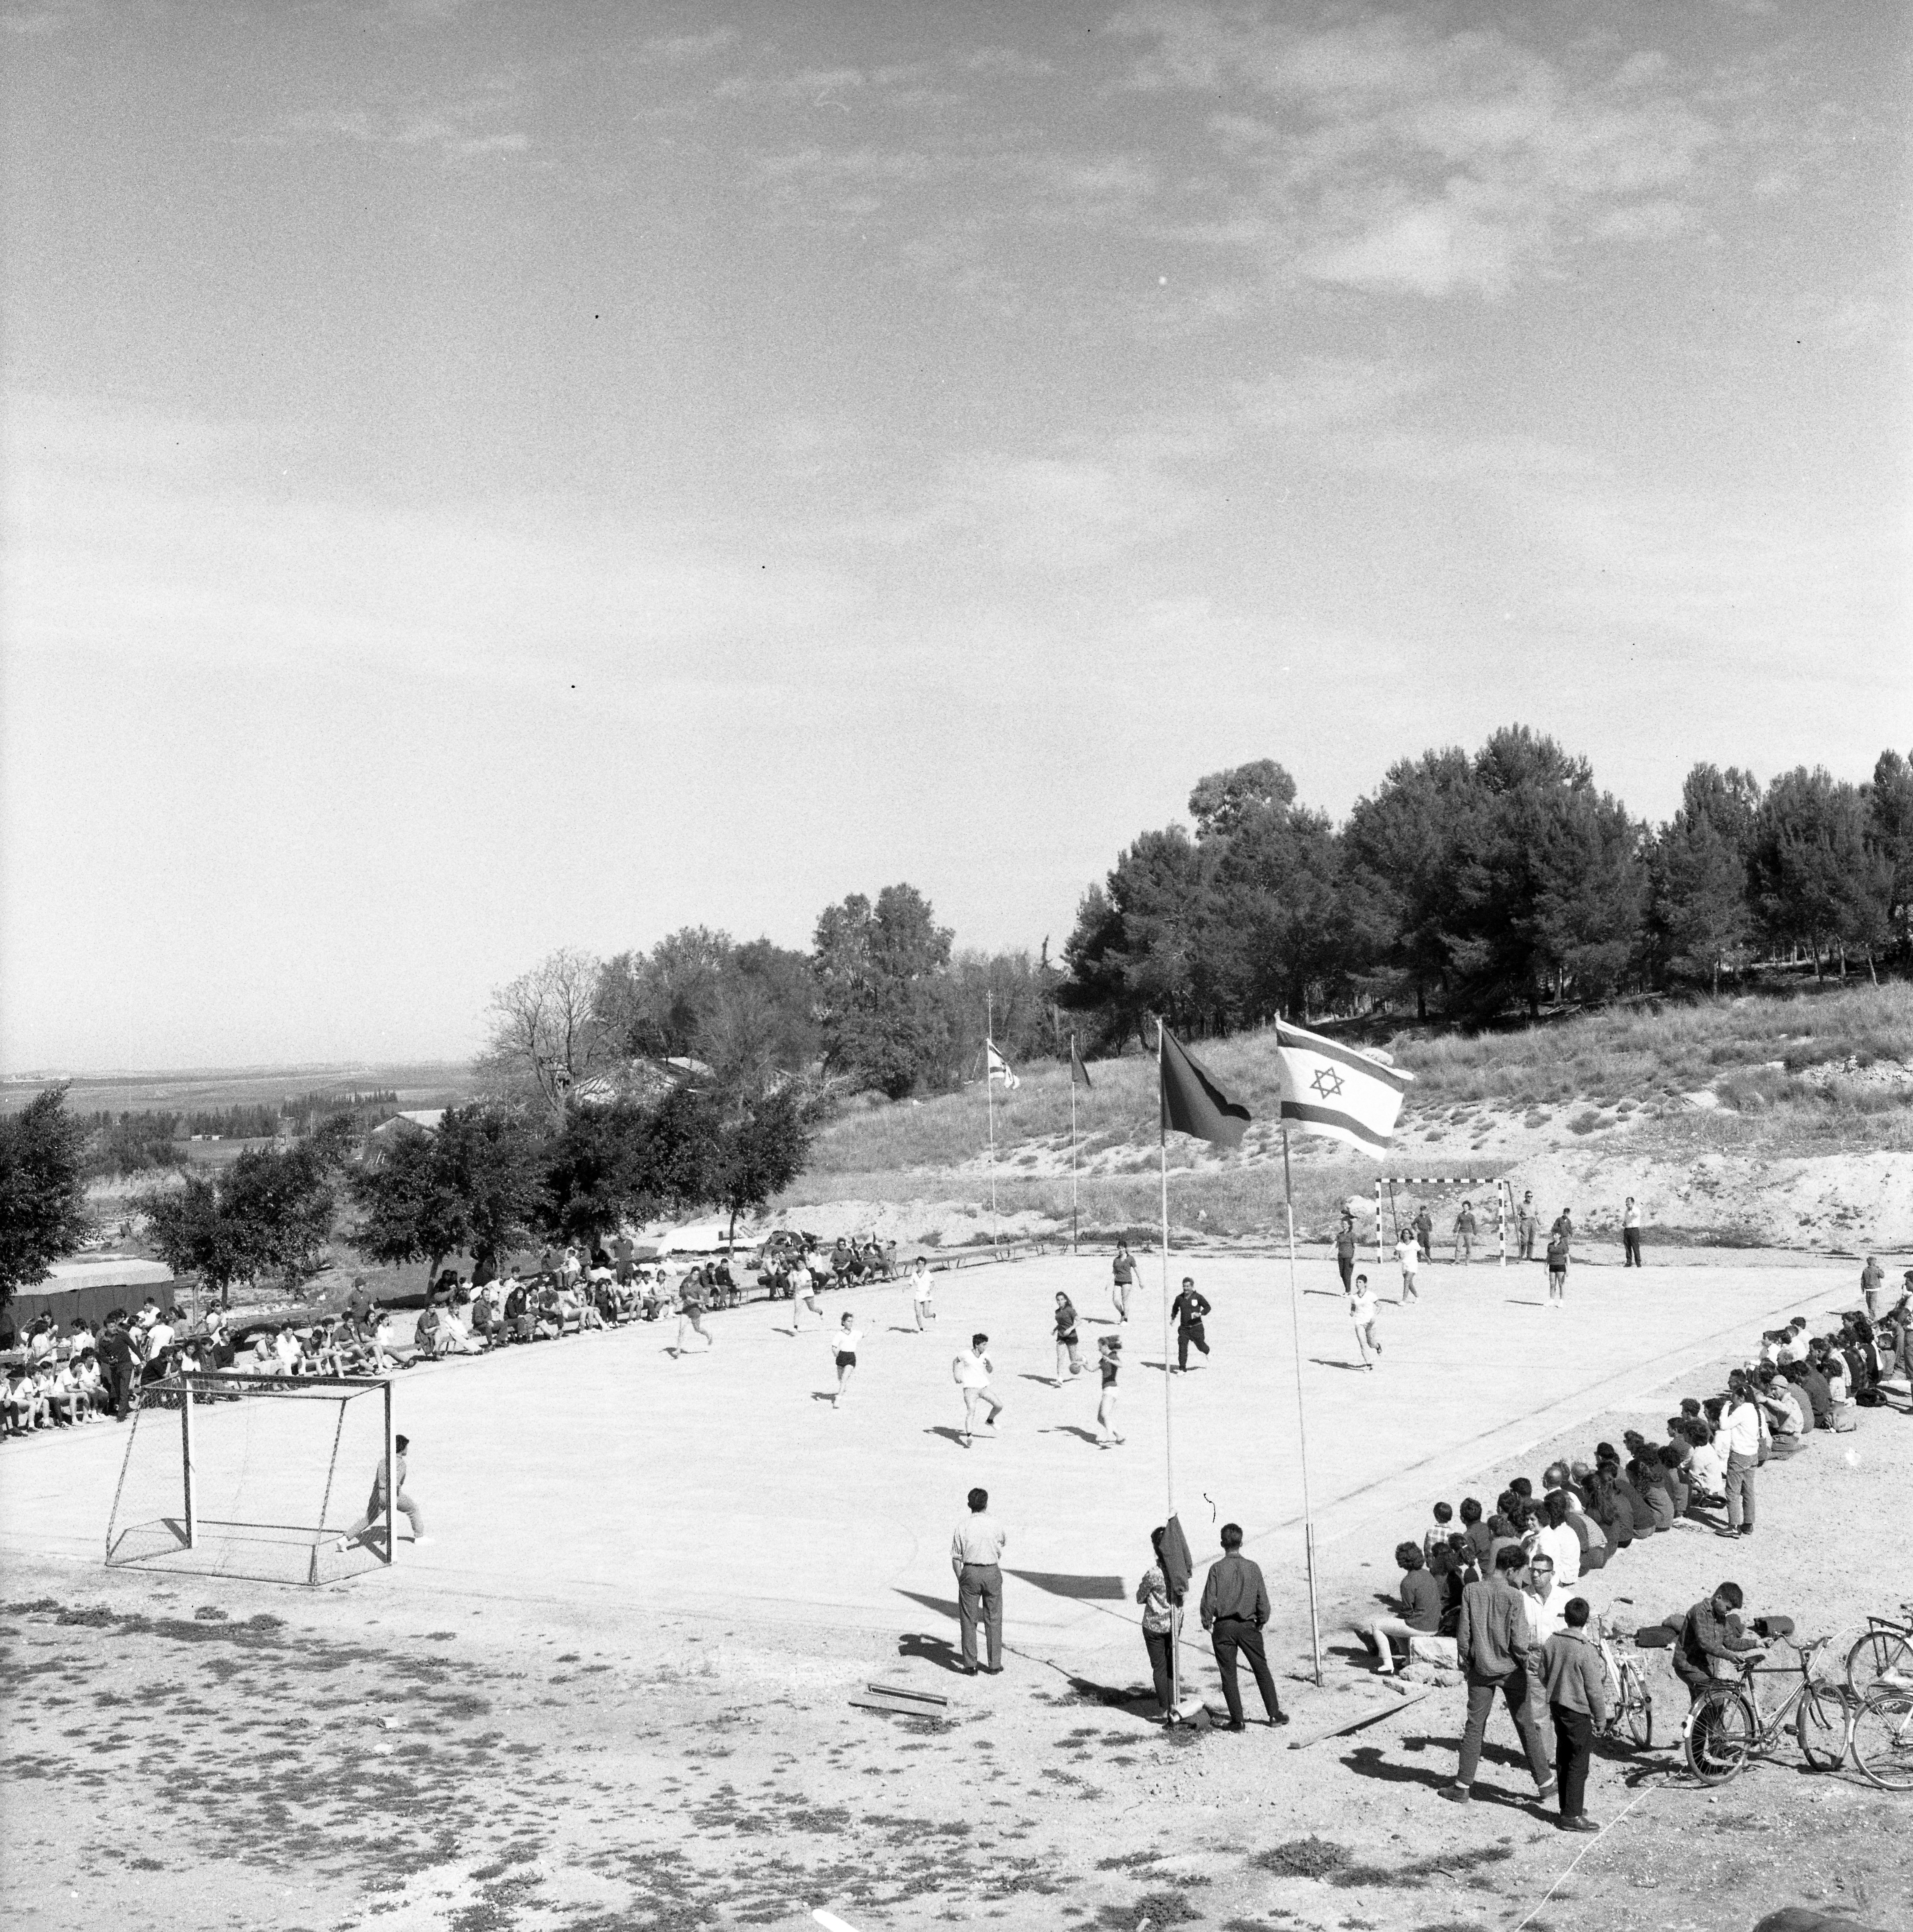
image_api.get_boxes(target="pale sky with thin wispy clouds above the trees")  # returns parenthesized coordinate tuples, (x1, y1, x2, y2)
(0, 0, 1913, 1072)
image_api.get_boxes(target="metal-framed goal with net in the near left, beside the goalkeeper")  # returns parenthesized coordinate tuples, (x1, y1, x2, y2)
(106, 1372, 392, 1584)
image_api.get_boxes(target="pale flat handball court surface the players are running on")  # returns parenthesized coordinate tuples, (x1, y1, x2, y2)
(0, 1254, 1855, 1667)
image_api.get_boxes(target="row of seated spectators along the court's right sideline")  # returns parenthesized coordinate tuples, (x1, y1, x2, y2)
(1357, 1300, 1913, 1671)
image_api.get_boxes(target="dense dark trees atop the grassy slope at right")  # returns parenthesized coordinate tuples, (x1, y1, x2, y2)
(1057, 726, 1913, 1047)
